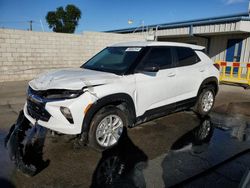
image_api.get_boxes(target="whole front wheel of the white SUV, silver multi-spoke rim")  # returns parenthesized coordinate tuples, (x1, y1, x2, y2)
(89, 106, 127, 150)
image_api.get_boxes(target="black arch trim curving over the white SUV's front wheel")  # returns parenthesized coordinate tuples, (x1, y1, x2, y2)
(82, 93, 136, 132)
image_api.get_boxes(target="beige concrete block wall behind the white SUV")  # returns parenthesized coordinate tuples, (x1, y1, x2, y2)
(0, 29, 143, 82)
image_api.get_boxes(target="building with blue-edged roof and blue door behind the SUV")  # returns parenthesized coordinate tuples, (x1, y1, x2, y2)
(108, 13, 250, 62)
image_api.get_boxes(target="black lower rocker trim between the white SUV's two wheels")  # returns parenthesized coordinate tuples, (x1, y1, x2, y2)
(136, 97, 197, 125)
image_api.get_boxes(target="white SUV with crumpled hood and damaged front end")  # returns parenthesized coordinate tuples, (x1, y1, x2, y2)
(24, 42, 219, 149)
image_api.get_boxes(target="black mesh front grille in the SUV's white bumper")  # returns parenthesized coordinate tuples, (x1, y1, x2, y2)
(27, 99, 51, 121)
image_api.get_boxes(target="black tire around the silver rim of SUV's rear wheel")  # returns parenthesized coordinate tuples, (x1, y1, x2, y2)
(194, 86, 215, 117)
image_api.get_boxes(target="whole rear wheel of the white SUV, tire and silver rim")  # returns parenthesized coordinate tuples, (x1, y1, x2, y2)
(194, 87, 215, 116)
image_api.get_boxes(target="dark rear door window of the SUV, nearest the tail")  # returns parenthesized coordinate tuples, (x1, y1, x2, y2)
(176, 47, 200, 67)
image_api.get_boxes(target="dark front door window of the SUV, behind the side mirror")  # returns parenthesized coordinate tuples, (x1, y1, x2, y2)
(141, 47, 172, 69)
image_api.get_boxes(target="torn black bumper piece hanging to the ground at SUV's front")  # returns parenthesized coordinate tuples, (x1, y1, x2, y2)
(5, 111, 49, 176)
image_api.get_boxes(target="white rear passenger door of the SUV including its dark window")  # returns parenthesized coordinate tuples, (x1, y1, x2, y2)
(175, 47, 205, 101)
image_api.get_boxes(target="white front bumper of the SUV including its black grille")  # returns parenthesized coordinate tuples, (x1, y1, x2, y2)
(23, 92, 97, 135)
